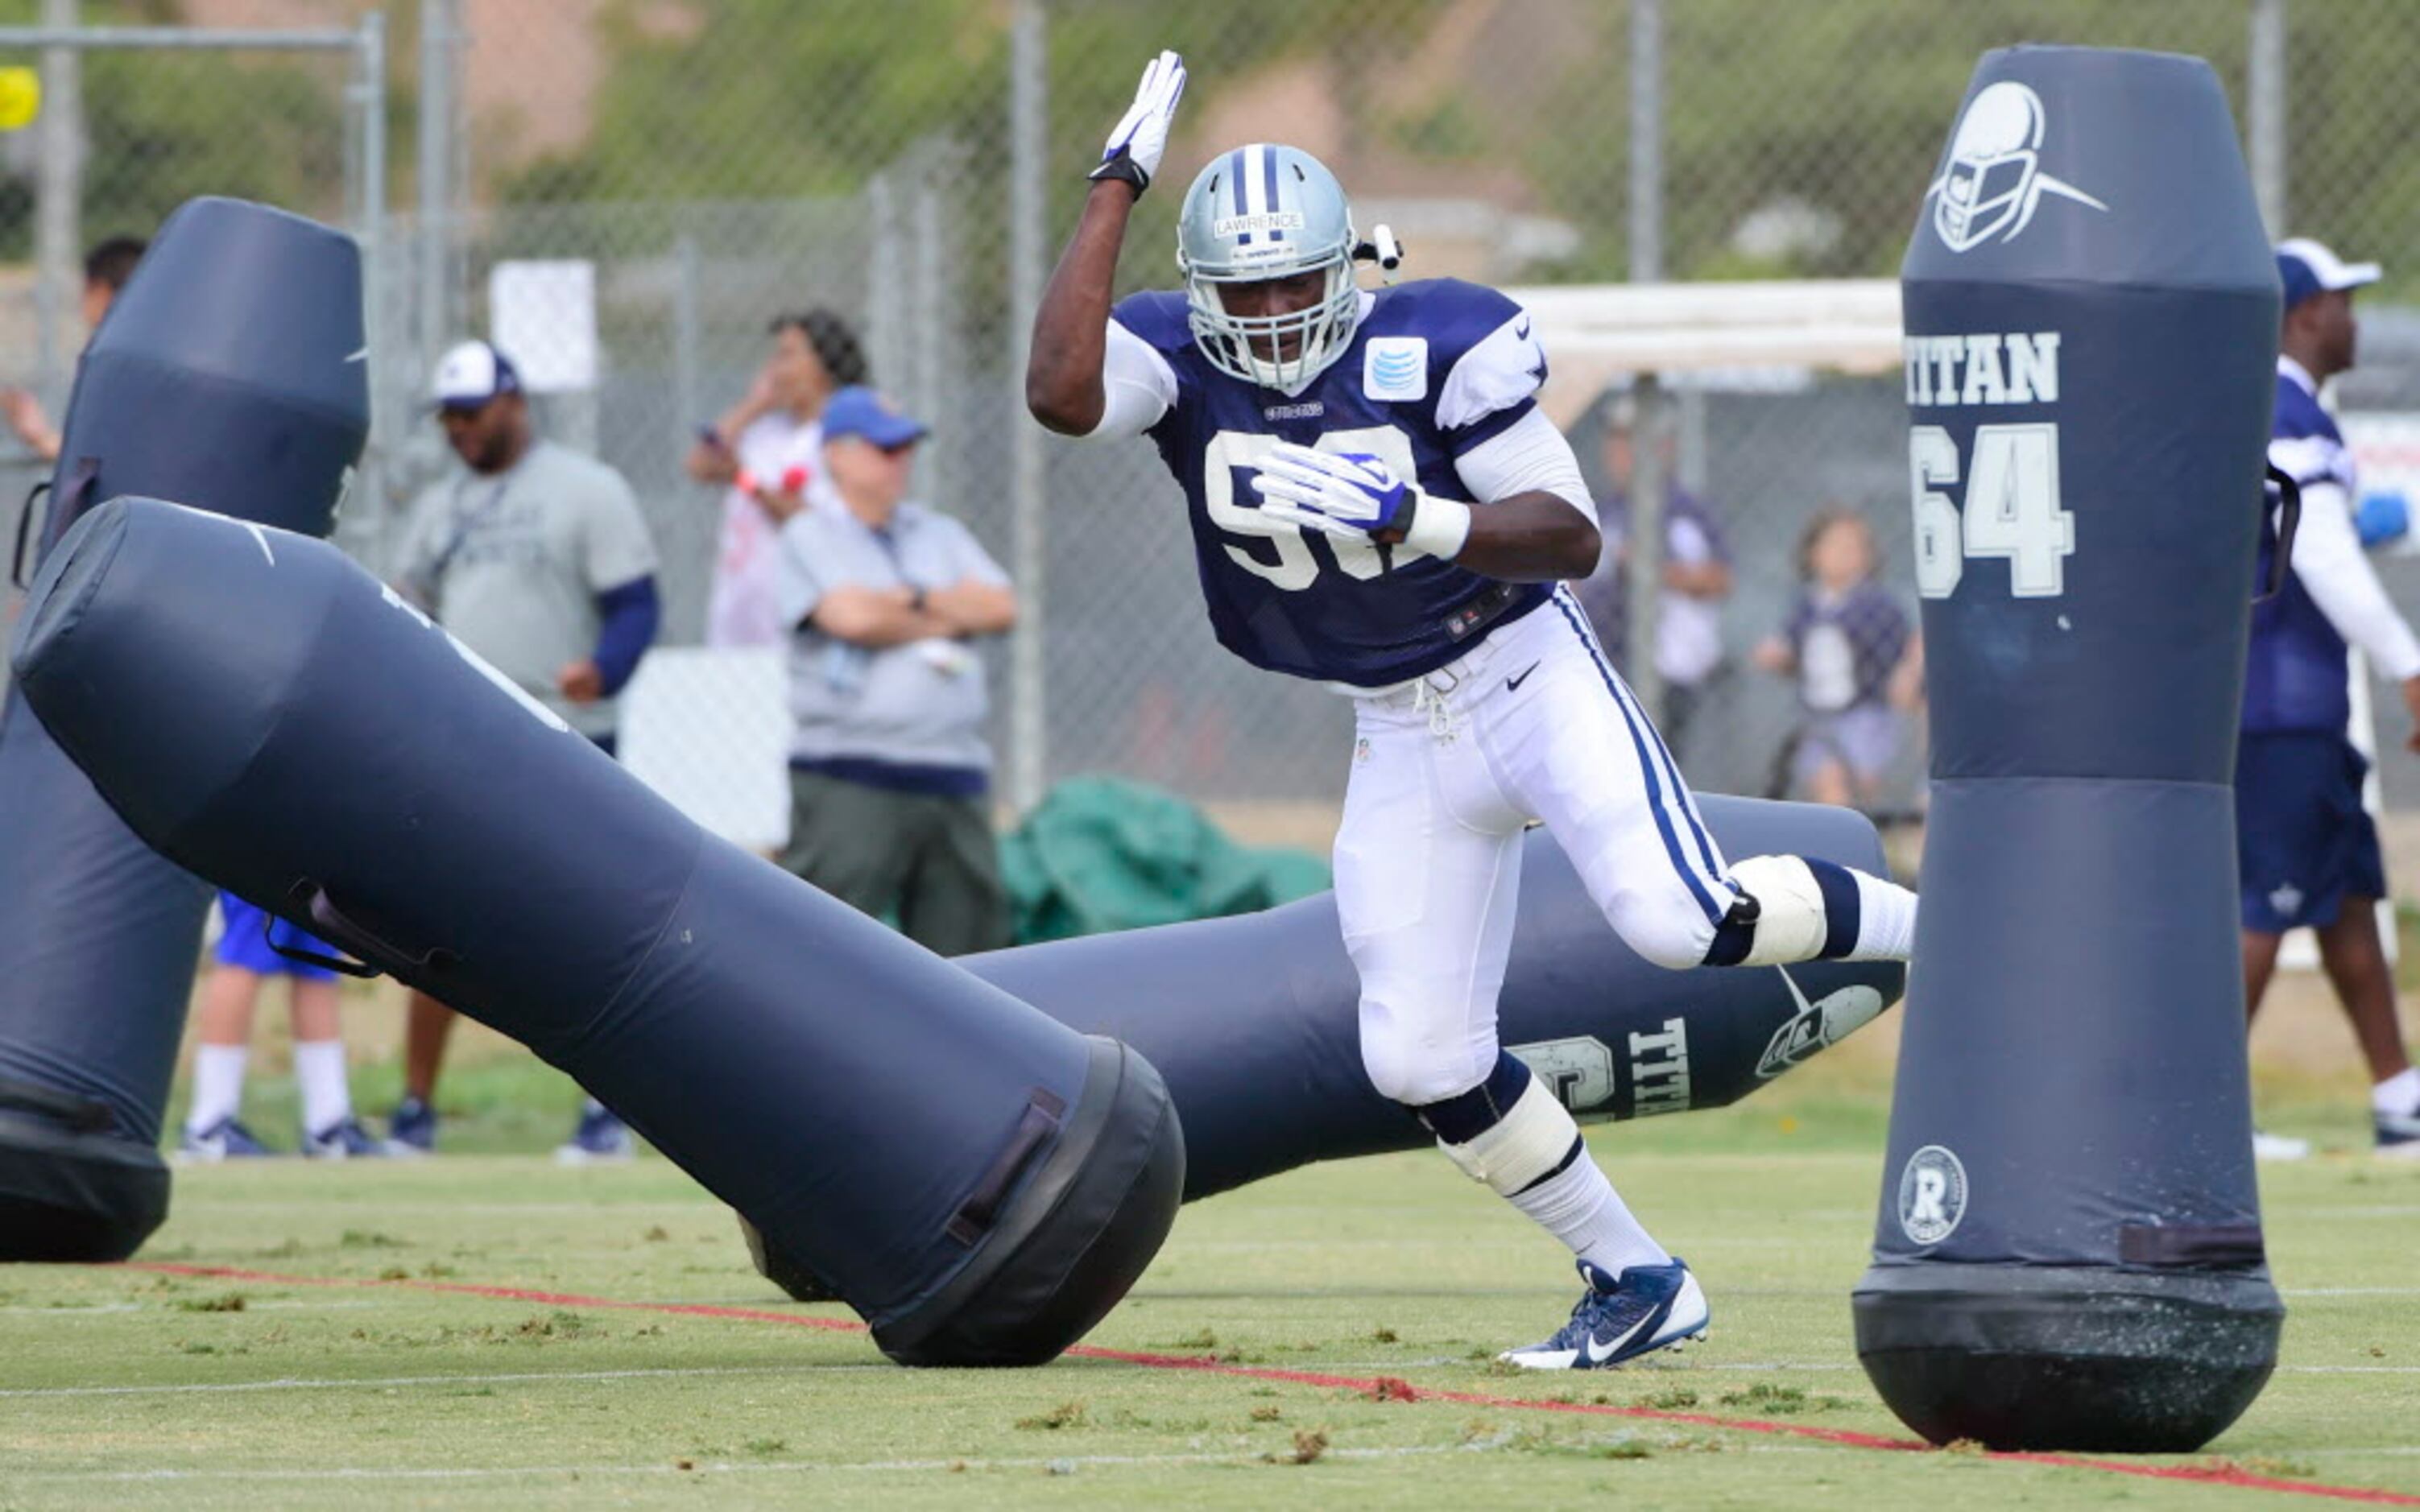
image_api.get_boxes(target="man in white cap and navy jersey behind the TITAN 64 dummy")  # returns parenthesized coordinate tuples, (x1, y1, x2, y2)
(2236, 237, 2420, 1159)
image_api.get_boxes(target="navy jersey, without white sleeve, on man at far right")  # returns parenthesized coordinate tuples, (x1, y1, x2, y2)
(2244, 362, 2355, 730)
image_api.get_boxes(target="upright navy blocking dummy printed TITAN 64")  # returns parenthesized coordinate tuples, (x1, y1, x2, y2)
(1854, 48, 2282, 1452)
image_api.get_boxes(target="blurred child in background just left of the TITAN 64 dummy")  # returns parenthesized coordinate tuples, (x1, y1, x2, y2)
(1755, 508, 1909, 808)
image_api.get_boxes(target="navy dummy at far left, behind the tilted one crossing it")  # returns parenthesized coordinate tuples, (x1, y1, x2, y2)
(0, 198, 370, 1261)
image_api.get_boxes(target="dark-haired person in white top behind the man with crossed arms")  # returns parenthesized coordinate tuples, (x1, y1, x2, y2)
(687, 310, 869, 646)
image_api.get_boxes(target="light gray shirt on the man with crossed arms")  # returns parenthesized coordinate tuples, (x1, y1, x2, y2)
(780, 501, 1009, 772)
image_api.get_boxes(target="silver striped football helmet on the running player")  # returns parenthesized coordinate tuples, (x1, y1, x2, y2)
(1176, 143, 1360, 392)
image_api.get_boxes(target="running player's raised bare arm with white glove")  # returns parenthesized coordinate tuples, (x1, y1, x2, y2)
(1026, 53, 1185, 436)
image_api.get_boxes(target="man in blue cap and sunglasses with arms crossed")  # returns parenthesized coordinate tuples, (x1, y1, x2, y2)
(780, 385, 1016, 956)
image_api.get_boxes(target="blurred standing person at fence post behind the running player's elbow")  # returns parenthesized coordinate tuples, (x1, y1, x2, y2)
(1570, 395, 1731, 752)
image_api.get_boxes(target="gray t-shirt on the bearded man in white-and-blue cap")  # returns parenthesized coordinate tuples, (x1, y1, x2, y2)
(402, 440, 656, 735)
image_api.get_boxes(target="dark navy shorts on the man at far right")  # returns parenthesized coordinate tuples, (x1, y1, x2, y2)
(2236, 730, 2386, 934)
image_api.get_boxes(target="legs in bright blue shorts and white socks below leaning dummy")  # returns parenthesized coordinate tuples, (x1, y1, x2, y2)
(176, 893, 385, 1161)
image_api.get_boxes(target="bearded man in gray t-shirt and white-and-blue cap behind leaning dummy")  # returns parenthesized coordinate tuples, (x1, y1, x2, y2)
(387, 341, 658, 1161)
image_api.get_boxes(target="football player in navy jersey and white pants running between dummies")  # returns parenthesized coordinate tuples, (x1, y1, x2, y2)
(1026, 53, 1917, 1369)
